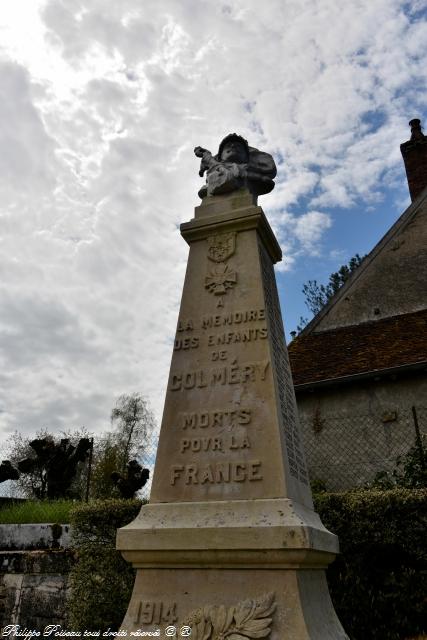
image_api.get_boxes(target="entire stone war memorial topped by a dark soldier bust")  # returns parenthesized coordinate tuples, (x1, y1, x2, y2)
(117, 134, 347, 640)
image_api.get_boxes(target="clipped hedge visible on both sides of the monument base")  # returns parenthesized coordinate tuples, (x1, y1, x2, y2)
(69, 489, 427, 640)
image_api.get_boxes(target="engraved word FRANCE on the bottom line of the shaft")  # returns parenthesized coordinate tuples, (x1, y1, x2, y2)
(170, 460, 263, 485)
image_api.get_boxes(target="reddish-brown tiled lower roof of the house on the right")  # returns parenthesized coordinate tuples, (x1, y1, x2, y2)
(288, 309, 427, 385)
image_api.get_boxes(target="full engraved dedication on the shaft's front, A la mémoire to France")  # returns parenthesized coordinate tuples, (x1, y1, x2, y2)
(169, 302, 271, 487)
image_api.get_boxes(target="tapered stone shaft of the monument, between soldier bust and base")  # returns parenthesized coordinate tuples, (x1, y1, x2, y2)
(146, 198, 311, 505)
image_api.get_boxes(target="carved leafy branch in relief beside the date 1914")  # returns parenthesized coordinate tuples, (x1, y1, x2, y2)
(182, 592, 276, 640)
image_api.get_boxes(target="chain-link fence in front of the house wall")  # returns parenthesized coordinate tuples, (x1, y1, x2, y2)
(300, 406, 427, 491)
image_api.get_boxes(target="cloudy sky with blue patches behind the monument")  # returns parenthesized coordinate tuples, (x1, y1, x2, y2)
(0, 0, 427, 450)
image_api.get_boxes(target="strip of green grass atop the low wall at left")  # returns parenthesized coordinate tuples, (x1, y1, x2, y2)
(0, 500, 79, 524)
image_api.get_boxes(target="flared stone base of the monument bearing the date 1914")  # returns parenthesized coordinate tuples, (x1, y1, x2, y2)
(117, 499, 347, 640)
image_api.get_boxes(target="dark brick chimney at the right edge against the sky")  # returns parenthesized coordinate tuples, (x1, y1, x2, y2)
(400, 118, 427, 202)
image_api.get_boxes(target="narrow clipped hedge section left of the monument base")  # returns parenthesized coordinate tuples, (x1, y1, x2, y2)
(67, 500, 142, 631)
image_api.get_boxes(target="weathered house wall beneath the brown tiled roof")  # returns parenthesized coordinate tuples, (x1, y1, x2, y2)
(297, 374, 427, 491)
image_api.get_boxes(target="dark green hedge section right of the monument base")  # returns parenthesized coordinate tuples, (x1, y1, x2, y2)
(315, 489, 427, 640)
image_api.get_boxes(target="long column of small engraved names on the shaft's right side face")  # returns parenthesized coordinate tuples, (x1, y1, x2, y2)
(259, 242, 308, 484)
